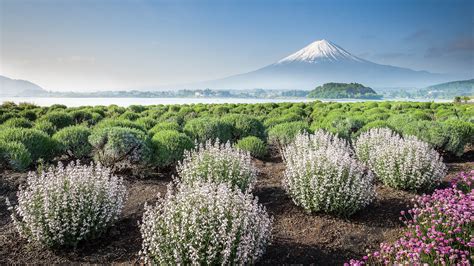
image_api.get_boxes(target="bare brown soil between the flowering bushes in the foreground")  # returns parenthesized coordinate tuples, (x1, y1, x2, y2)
(0, 150, 474, 265)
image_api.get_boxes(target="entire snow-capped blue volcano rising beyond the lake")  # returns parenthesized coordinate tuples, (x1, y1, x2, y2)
(188, 40, 450, 90)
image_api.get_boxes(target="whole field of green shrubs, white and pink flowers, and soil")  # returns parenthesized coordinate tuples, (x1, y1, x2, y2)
(0, 102, 474, 265)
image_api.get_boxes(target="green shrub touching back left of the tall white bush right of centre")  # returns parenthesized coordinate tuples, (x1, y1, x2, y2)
(268, 122, 309, 147)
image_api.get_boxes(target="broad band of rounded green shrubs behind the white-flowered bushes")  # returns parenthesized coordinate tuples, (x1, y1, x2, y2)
(0, 101, 474, 169)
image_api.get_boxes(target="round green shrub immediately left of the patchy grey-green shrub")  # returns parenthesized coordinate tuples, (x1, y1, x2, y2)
(53, 126, 92, 159)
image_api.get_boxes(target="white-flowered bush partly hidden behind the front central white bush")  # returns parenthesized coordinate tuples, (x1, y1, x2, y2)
(177, 140, 256, 191)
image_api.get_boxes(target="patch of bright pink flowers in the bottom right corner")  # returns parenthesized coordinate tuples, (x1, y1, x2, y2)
(345, 170, 474, 265)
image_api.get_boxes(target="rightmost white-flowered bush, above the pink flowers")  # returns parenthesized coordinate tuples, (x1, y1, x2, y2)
(354, 128, 446, 190)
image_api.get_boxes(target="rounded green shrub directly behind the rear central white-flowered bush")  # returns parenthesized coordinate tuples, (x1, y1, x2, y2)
(184, 117, 233, 142)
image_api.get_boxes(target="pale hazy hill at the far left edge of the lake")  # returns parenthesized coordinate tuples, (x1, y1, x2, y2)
(0, 76, 46, 96)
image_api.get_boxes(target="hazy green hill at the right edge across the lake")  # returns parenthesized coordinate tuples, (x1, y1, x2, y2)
(422, 79, 474, 98)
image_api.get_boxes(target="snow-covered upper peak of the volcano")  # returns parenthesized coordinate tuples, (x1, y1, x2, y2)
(278, 39, 364, 64)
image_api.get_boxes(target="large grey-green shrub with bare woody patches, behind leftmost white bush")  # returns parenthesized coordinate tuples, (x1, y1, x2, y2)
(89, 127, 153, 171)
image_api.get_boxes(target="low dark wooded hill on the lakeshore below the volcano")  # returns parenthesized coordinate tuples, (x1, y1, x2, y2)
(308, 83, 382, 99)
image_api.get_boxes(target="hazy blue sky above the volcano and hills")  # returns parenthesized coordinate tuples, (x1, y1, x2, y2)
(0, 0, 474, 91)
